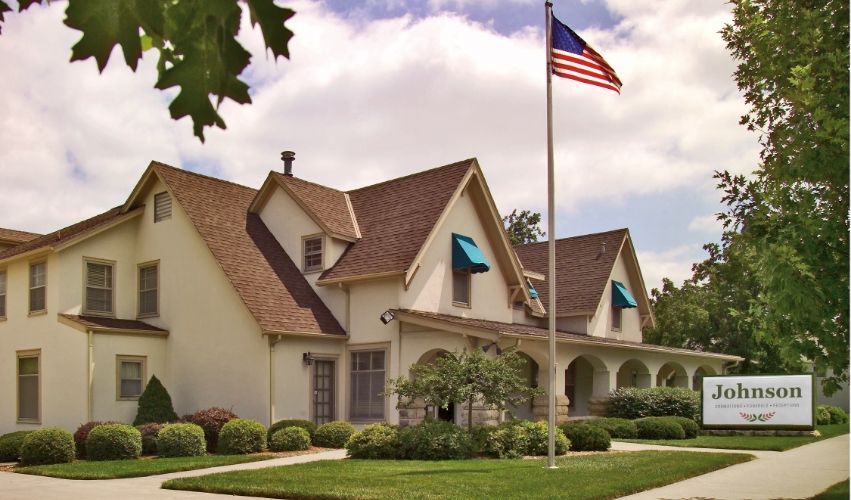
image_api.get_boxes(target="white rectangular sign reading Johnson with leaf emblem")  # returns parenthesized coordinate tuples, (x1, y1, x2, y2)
(702, 375, 815, 429)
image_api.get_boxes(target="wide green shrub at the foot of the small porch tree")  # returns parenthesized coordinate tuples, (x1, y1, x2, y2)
(398, 420, 473, 460)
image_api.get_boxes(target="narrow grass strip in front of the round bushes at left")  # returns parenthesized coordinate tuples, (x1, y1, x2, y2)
(14, 454, 275, 479)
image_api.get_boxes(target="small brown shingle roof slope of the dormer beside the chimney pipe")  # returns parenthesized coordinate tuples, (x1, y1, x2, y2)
(273, 172, 358, 239)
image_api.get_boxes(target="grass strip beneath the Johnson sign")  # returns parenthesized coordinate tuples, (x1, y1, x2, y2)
(618, 424, 848, 451)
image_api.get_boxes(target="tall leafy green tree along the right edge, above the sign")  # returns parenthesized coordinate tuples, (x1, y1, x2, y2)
(716, 0, 849, 392)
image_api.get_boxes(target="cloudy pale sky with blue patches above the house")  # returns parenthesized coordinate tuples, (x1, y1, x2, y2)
(0, 0, 759, 290)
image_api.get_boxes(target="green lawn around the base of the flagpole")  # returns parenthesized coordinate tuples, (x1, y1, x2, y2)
(163, 451, 753, 500)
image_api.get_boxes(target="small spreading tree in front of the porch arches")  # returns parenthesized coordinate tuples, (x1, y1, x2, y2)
(386, 349, 542, 428)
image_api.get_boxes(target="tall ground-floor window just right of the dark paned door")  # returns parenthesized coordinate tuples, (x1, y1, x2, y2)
(350, 350, 385, 420)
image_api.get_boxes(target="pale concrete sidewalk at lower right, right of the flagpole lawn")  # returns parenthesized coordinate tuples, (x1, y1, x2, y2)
(618, 434, 849, 500)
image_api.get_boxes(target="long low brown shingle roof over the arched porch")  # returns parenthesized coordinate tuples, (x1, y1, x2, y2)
(394, 309, 743, 360)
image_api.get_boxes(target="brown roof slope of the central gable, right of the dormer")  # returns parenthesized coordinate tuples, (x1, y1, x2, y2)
(320, 159, 475, 281)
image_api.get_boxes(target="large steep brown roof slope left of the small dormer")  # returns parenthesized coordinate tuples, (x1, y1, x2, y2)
(152, 162, 345, 335)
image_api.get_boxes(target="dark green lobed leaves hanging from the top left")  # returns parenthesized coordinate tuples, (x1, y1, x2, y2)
(0, 0, 295, 142)
